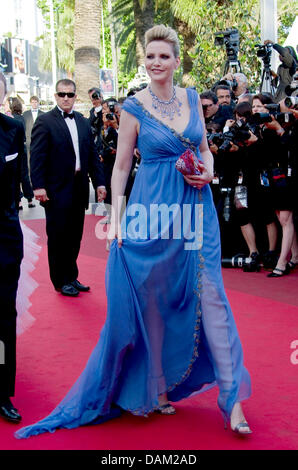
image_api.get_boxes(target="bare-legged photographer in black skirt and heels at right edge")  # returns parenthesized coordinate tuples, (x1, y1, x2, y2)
(252, 94, 298, 278)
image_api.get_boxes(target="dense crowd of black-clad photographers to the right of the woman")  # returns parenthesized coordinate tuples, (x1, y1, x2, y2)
(200, 41, 298, 277)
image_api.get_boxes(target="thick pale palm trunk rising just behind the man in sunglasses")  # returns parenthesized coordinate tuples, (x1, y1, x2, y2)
(74, 0, 101, 102)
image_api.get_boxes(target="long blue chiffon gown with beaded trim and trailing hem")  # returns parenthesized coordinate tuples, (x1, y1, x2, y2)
(16, 89, 251, 438)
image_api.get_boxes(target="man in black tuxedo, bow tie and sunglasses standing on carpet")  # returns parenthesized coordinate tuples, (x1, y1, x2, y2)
(30, 79, 106, 297)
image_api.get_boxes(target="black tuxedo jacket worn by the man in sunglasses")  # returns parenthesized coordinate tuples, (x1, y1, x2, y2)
(30, 106, 105, 208)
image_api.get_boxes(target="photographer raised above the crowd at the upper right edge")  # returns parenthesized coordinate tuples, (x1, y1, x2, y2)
(264, 39, 298, 103)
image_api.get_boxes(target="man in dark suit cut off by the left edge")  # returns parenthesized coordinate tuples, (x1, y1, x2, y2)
(0, 73, 25, 423)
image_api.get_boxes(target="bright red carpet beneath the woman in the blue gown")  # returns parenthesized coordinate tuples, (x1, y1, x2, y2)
(0, 216, 298, 450)
